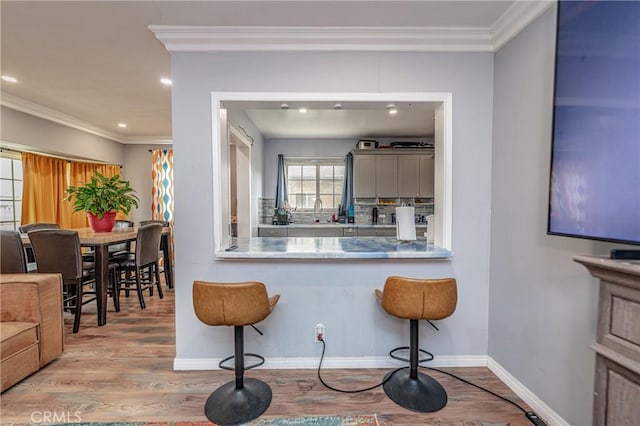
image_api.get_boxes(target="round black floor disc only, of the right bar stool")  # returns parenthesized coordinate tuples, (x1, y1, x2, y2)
(382, 369, 447, 413)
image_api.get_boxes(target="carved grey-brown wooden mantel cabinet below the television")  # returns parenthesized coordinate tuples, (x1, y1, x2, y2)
(574, 256, 640, 426)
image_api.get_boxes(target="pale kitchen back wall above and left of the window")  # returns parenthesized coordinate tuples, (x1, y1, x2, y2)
(264, 139, 357, 198)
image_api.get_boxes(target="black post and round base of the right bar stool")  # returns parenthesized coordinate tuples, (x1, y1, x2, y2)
(382, 320, 447, 413)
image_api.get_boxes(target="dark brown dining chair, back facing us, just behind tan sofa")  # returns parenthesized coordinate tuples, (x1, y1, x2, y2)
(28, 229, 120, 333)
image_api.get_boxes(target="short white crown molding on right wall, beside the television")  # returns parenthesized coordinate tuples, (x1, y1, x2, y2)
(491, 0, 556, 52)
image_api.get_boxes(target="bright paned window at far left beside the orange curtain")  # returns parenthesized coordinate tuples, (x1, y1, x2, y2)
(0, 152, 22, 231)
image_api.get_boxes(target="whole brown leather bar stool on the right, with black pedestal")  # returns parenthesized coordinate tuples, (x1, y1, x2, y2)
(375, 276, 458, 413)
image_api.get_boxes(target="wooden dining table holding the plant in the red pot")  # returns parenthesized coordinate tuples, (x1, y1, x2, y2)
(22, 227, 173, 326)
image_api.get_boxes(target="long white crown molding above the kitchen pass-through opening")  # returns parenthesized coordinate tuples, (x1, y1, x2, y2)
(149, 25, 492, 52)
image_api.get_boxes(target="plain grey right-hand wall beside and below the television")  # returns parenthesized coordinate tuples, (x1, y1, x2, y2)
(489, 8, 632, 425)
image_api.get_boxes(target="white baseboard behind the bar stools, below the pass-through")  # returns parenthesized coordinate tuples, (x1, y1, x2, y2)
(173, 355, 487, 370)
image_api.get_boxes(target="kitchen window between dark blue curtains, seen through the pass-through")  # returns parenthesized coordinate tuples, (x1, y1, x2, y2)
(286, 159, 344, 210)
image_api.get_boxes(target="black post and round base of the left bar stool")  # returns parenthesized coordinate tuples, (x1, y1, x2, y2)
(204, 326, 272, 425)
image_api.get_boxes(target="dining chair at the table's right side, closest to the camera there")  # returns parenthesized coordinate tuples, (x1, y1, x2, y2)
(115, 223, 164, 309)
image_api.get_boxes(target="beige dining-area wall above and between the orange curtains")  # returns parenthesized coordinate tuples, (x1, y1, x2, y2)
(0, 106, 171, 222)
